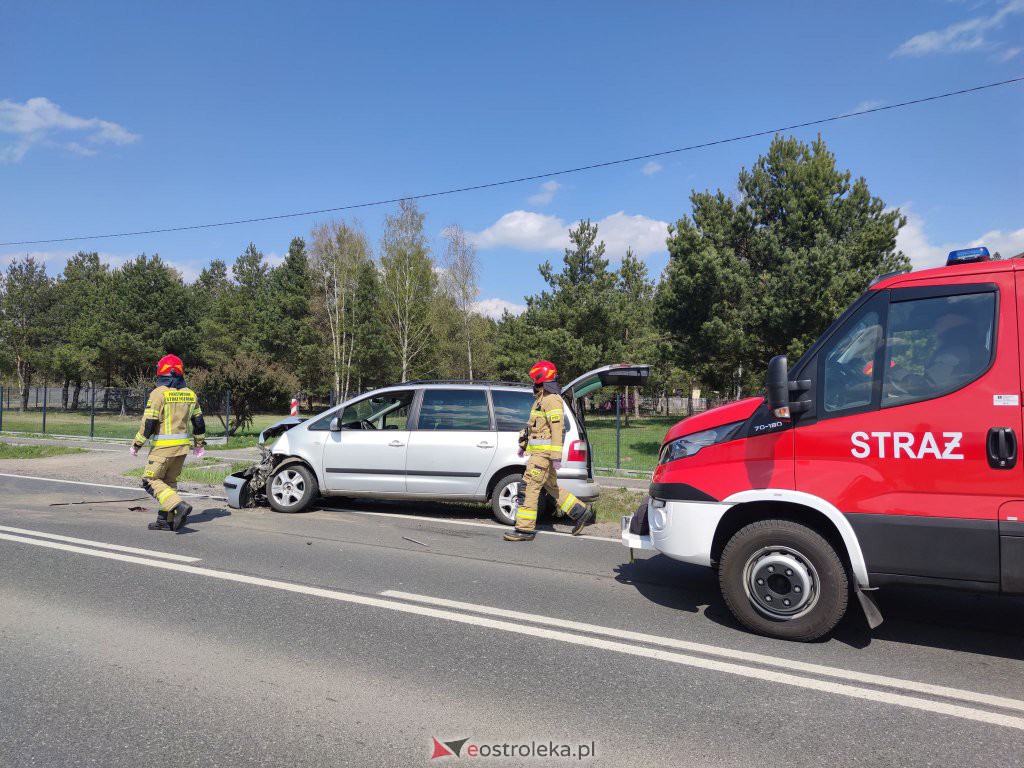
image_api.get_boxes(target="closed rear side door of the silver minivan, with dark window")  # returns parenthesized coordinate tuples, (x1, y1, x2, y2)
(406, 387, 498, 498)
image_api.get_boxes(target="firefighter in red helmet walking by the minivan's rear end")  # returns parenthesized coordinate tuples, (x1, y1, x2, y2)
(505, 360, 594, 542)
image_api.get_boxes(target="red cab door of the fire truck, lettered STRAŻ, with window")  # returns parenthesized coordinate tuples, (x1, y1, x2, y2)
(795, 272, 1021, 583)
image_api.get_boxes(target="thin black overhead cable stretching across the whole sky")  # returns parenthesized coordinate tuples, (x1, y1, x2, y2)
(0, 76, 1024, 247)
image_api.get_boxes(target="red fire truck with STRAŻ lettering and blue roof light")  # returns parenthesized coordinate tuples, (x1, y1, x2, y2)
(622, 248, 1024, 640)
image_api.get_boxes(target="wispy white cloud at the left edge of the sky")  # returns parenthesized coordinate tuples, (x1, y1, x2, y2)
(0, 96, 139, 163)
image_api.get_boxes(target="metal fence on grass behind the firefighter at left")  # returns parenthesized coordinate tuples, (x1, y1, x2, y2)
(0, 386, 231, 440)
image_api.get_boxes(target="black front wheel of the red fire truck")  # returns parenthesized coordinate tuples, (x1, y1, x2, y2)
(718, 520, 850, 641)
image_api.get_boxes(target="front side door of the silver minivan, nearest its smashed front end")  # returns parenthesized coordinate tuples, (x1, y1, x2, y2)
(319, 389, 416, 495)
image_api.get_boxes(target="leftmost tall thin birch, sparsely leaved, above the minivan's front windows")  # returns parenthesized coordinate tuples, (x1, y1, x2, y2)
(309, 220, 371, 399)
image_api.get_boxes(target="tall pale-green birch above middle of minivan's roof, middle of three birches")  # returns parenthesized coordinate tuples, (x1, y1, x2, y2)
(380, 200, 437, 381)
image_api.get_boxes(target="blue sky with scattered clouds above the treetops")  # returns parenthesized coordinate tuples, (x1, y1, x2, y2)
(0, 0, 1024, 311)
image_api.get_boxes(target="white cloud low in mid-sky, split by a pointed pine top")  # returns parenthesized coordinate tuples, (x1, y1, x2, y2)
(470, 211, 669, 260)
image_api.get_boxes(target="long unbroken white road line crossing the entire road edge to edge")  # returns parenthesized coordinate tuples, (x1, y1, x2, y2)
(0, 534, 1024, 730)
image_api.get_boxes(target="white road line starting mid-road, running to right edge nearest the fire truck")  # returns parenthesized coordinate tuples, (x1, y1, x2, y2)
(380, 590, 1024, 712)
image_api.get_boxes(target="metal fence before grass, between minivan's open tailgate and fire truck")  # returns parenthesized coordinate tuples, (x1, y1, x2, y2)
(586, 394, 730, 475)
